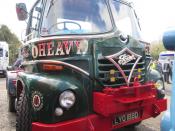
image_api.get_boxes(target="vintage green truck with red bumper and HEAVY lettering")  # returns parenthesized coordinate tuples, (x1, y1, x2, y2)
(16, 0, 167, 131)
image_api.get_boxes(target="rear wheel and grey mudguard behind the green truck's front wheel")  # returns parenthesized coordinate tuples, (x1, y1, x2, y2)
(6, 58, 22, 112)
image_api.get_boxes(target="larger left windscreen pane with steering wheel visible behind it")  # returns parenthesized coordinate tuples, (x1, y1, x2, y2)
(41, 0, 112, 35)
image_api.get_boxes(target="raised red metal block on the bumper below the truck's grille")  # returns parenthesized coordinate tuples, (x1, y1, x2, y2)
(93, 83, 166, 117)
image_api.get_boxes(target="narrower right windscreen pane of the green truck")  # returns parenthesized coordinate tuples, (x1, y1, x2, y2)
(110, 0, 140, 39)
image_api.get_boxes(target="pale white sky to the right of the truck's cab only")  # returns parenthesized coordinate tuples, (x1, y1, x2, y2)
(133, 0, 175, 41)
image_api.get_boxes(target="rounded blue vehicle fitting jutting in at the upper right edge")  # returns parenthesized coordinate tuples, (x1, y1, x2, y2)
(163, 29, 175, 50)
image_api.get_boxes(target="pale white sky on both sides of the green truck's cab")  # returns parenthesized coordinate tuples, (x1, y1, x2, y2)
(0, 0, 175, 42)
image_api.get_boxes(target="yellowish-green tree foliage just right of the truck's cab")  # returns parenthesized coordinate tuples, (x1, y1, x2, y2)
(150, 42, 166, 60)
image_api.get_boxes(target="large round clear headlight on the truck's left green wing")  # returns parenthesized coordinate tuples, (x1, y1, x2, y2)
(59, 90, 75, 109)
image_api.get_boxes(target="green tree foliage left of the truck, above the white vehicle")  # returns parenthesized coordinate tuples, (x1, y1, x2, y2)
(0, 25, 21, 64)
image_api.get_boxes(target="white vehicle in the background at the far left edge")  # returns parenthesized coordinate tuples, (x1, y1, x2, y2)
(0, 41, 9, 75)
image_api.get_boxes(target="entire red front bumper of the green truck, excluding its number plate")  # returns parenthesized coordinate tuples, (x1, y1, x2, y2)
(32, 83, 167, 131)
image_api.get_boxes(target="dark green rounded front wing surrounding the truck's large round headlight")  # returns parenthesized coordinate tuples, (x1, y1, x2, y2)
(20, 65, 92, 123)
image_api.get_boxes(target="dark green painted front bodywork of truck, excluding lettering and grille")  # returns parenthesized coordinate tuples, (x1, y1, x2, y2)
(17, 0, 162, 123)
